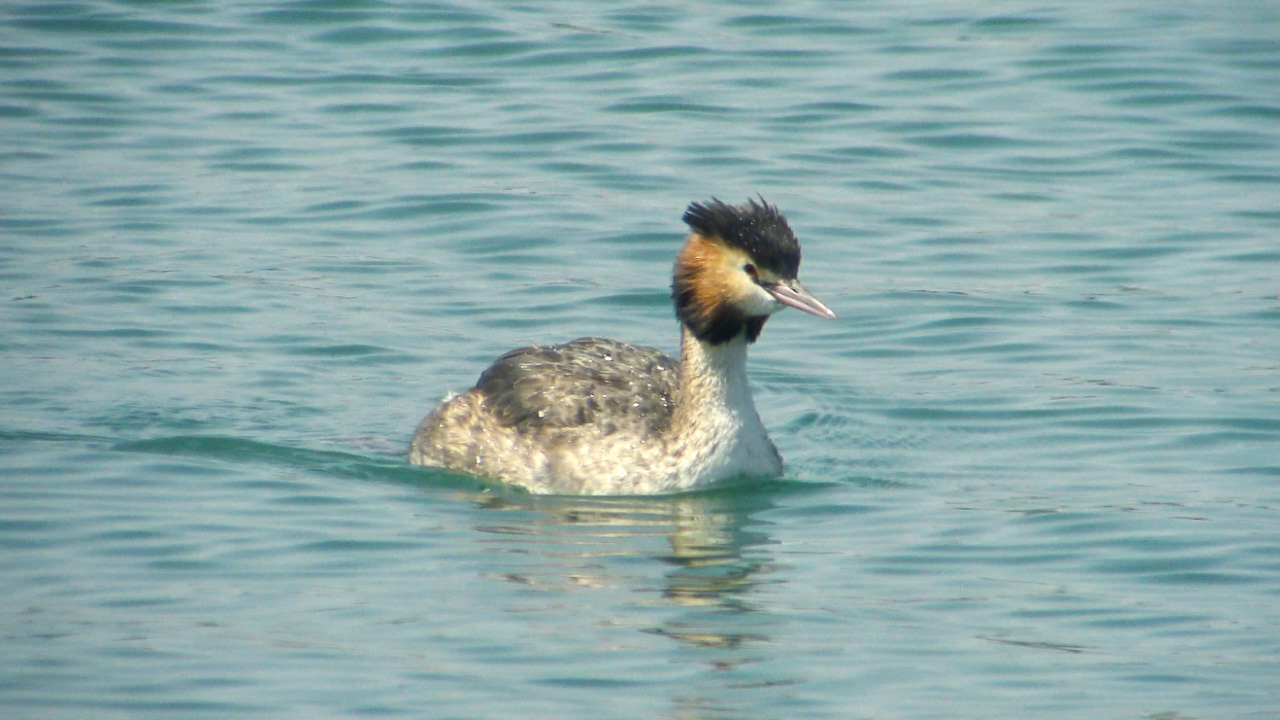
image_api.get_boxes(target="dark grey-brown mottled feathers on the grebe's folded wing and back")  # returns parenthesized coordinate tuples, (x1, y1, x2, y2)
(476, 337, 680, 433)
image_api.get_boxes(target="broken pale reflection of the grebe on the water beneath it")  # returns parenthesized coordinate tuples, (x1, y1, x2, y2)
(476, 488, 773, 650)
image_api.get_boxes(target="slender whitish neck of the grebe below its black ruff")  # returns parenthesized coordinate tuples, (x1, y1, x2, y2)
(672, 325, 760, 427)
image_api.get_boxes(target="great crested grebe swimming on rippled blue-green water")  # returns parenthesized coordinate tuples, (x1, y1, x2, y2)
(408, 199, 836, 495)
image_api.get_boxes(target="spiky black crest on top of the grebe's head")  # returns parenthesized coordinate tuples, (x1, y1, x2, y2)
(684, 197, 800, 278)
